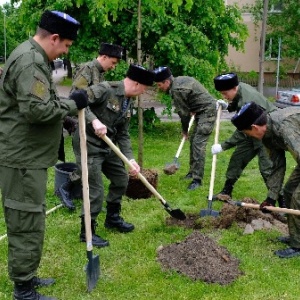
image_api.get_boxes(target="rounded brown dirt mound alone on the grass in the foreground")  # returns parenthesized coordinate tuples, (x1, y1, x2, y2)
(158, 231, 243, 285)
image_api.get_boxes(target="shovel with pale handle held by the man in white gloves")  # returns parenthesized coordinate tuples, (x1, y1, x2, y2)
(200, 105, 222, 217)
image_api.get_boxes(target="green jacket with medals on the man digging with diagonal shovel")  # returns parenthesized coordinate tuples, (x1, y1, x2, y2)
(74, 81, 133, 159)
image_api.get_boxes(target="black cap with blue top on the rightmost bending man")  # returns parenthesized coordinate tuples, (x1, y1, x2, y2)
(231, 102, 265, 131)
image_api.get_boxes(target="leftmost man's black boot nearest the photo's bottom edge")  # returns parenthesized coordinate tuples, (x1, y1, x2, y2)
(14, 280, 57, 300)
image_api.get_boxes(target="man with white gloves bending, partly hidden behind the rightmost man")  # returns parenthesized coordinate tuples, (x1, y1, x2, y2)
(212, 73, 284, 206)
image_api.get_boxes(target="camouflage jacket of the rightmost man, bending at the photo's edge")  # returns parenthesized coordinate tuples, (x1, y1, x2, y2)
(262, 107, 300, 200)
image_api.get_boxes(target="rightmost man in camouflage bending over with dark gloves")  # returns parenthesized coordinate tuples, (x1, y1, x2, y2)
(232, 102, 300, 258)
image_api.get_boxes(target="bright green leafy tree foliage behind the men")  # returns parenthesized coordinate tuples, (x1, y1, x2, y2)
(5, 0, 247, 89)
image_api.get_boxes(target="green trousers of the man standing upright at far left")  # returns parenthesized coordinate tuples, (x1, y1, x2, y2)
(0, 166, 47, 282)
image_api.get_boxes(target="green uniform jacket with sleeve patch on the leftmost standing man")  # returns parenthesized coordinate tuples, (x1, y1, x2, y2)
(0, 39, 77, 169)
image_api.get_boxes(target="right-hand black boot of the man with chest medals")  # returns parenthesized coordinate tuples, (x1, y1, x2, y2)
(104, 202, 134, 232)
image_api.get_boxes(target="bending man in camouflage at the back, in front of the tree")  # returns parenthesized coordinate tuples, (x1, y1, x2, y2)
(154, 67, 227, 190)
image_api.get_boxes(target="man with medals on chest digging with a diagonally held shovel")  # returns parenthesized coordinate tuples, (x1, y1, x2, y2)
(73, 65, 154, 247)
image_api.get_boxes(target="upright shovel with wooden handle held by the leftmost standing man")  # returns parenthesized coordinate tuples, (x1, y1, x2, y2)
(78, 109, 100, 292)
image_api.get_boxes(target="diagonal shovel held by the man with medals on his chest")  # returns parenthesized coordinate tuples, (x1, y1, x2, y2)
(101, 135, 186, 220)
